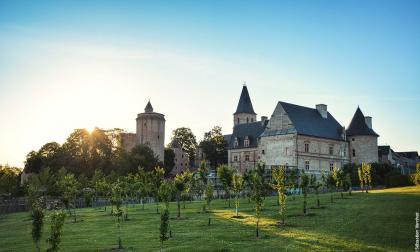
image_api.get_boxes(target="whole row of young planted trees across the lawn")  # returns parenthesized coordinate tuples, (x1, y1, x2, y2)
(27, 162, 371, 251)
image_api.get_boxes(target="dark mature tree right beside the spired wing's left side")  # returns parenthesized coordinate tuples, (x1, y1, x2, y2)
(199, 126, 227, 167)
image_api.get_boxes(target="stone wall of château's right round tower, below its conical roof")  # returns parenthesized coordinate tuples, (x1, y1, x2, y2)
(347, 136, 378, 164)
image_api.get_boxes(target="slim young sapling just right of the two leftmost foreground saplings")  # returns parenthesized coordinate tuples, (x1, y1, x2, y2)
(59, 173, 80, 222)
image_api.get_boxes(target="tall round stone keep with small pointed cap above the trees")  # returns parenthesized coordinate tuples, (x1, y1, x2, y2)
(136, 101, 165, 162)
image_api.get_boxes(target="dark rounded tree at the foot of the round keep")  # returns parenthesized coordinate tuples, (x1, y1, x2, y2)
(130, 144, 159, 172)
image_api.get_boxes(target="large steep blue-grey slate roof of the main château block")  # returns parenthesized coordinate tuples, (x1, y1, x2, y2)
(279, 101, 343, 141)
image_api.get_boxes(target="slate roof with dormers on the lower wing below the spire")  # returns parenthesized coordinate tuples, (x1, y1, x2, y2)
(229, 120, 268, 149)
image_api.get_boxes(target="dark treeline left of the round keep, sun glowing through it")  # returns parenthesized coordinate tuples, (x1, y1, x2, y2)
(24, 128, 173, 178)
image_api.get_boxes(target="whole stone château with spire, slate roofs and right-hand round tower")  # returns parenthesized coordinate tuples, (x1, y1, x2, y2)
(228, 85, 378, 175)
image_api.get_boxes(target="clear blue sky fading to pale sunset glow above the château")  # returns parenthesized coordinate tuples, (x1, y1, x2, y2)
(0, 0, 420, 167)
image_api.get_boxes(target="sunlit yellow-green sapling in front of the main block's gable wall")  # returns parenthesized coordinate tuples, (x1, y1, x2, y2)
(271, 165, 288, 225)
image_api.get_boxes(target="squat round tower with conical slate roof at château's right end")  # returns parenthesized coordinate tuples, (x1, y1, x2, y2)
(346, 107, 379, 164)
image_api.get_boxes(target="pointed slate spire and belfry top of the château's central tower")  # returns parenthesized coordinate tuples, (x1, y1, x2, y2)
(233, 84, 257, 125)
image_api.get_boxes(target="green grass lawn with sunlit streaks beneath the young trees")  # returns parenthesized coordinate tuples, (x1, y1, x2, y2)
(0, 187, 420, 251)
